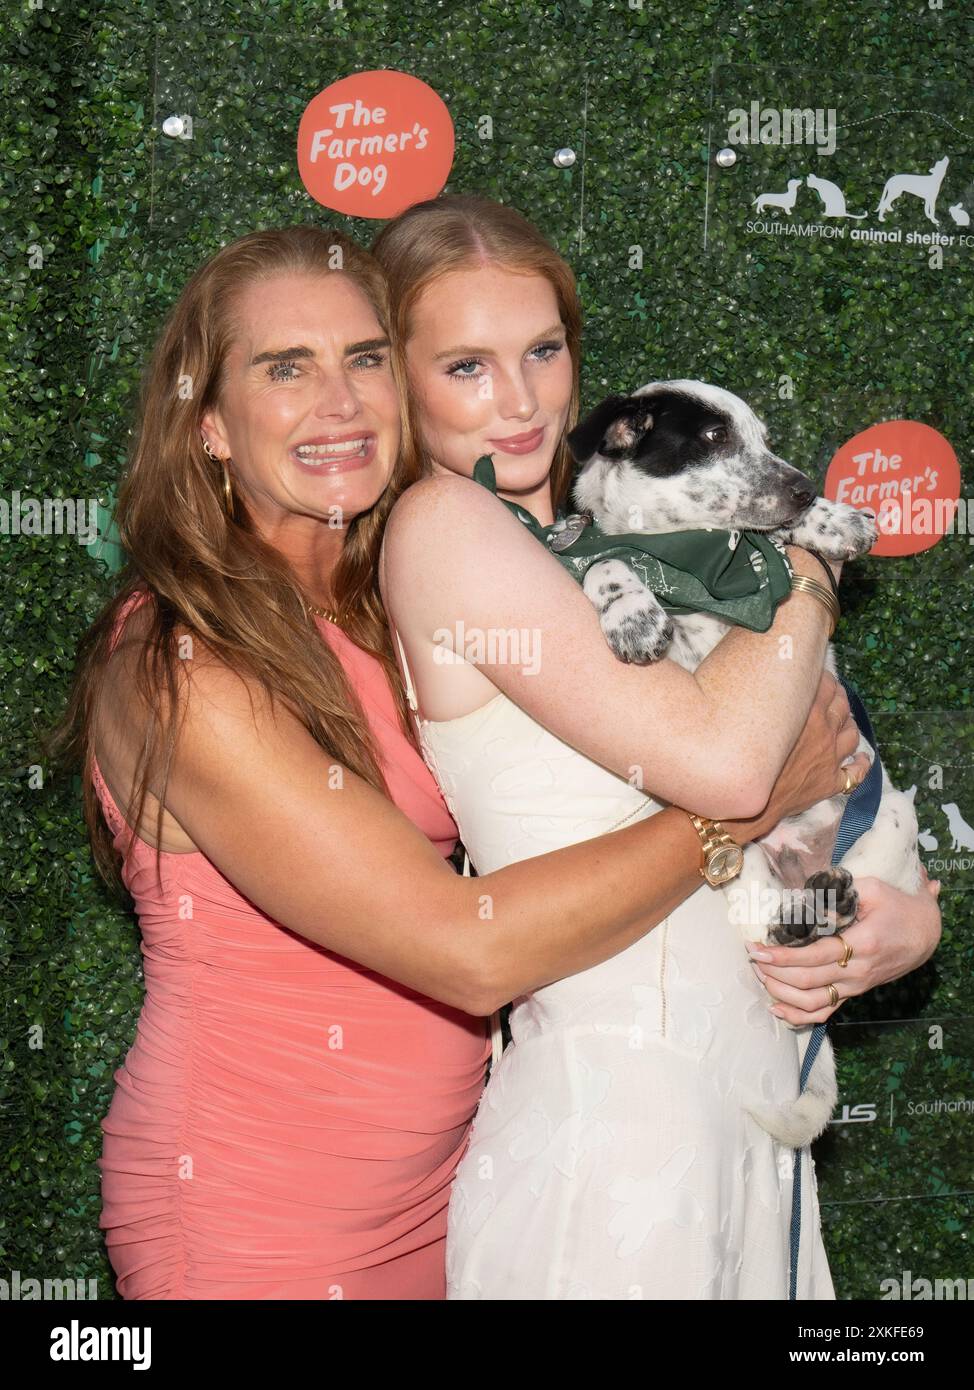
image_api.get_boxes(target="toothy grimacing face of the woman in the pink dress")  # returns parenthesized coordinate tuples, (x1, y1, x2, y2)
(201, 272, 400, 536)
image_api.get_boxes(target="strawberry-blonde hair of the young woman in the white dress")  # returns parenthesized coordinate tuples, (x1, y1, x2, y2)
(372, 193, 582, 513)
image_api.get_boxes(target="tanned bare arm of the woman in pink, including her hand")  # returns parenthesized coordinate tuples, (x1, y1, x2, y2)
(142, 642, 857, 1015)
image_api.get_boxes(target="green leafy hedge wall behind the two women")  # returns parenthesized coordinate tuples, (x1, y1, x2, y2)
(0, 0, 974, 1298)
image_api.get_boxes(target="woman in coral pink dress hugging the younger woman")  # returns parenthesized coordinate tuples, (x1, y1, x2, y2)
(45, 228, 894, 1300)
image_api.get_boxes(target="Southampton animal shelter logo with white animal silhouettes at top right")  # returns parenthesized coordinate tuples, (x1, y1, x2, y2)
(718, 100, 974, 264)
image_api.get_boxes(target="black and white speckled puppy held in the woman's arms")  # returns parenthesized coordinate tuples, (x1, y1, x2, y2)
(568, 381, 921, 1148)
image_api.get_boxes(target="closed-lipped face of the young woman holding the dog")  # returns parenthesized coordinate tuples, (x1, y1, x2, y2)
(406, 265, 572, 520)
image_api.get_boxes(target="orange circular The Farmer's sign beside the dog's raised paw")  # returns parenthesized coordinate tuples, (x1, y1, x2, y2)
(823, 420, 960, 555)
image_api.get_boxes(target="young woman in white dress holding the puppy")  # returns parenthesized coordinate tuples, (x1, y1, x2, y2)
(374, 196, 935, 1300)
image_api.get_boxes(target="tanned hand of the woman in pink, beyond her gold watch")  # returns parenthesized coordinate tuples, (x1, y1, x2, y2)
(721, 671, 871, 845)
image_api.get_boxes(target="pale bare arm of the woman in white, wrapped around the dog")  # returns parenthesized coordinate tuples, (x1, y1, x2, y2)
(382, 475, 834, 819)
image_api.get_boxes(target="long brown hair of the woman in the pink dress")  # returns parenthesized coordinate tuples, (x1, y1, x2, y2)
(42, 227, 417, 888)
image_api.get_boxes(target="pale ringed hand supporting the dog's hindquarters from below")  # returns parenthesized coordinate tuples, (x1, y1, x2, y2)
(748, 869, 941, 1024)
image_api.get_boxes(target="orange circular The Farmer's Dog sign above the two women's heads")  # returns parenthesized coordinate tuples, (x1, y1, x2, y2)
(297, 68, 454, 217)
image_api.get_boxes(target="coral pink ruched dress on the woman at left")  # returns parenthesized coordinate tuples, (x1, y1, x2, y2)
(92, 594, 490, 1300)
